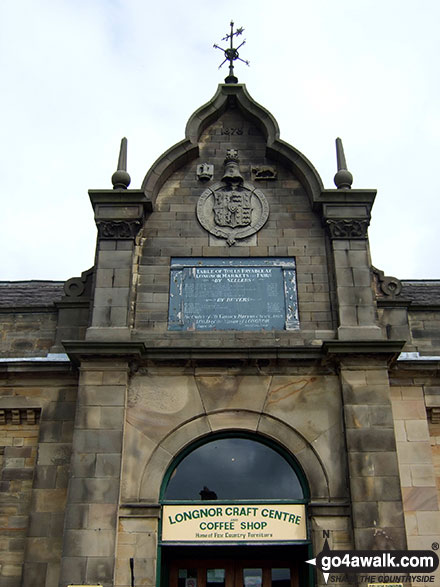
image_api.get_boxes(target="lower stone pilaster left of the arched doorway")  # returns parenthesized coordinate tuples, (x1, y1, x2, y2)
(60, 359, 128, 587)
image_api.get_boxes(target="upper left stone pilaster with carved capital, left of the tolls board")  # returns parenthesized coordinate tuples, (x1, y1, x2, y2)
(86, 189, 151, 340)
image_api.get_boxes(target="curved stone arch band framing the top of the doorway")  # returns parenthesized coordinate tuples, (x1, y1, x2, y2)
(138, 410, 330, 502)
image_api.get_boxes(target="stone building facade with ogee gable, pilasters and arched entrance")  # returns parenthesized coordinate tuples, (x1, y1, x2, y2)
(0, 83, 440, 587)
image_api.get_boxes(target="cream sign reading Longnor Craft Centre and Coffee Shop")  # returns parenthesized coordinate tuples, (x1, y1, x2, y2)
(162, 504, 307, 542)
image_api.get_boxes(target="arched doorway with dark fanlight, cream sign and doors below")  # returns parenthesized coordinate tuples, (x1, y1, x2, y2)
(159, 432, 312, 587)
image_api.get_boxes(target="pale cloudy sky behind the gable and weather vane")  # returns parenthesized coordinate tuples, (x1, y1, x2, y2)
(0, 0, 440, 281)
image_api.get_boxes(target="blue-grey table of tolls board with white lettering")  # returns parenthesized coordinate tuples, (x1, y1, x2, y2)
(168, 257, 299, 330)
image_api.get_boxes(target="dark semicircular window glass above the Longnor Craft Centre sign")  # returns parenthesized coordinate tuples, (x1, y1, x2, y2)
(164, 438, 303, 500)
